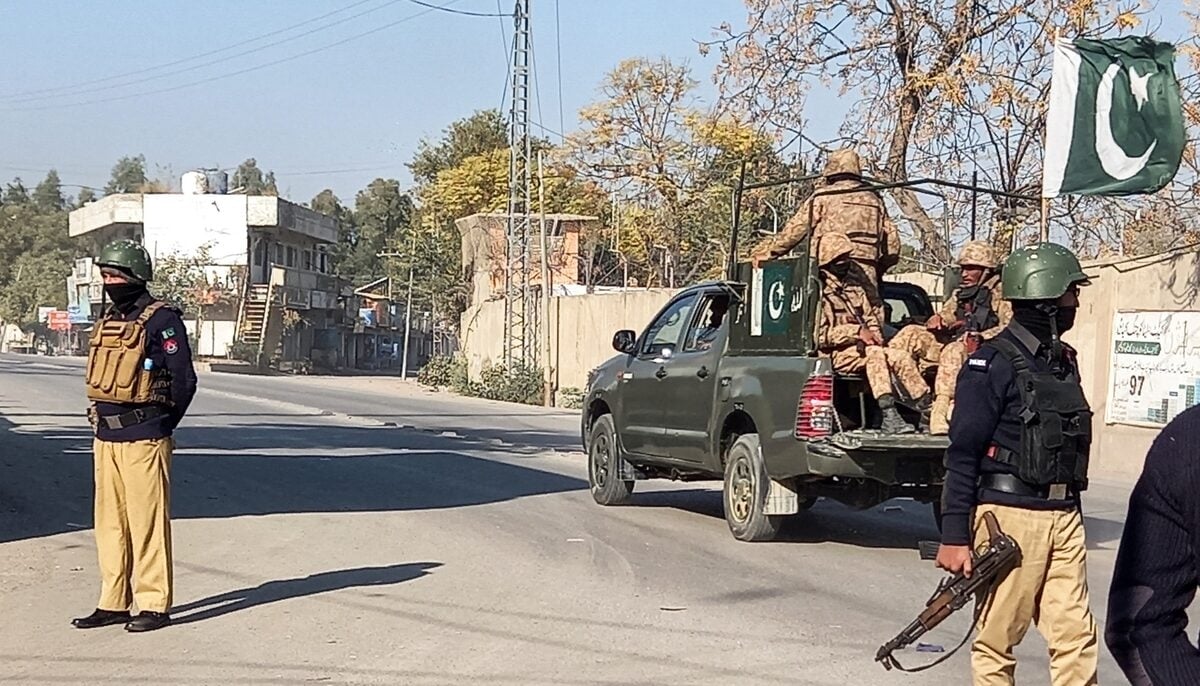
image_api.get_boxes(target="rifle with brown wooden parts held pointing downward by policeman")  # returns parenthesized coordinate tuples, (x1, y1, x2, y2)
(875, 512, 1021, 672)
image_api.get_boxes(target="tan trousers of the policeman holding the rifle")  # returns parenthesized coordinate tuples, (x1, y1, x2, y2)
(971, 505, 1099, 686)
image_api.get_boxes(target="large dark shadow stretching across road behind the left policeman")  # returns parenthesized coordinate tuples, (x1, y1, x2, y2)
(0, 417, 587, 543)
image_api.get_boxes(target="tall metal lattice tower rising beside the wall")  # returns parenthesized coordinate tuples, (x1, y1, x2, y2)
(504, 0, 536, 366)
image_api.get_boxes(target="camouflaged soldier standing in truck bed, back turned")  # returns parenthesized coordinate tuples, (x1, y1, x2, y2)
(750, 149, 900, 307)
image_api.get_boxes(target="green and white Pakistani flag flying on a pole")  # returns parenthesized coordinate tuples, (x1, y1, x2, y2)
(1042, 37, 1184, 198)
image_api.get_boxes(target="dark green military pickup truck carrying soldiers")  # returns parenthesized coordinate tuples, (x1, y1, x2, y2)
(582, 253, 948, 541)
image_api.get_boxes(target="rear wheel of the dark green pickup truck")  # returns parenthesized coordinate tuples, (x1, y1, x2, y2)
(722, 433, 784, 541)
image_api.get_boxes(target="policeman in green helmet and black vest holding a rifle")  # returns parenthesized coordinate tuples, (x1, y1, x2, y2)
(937, 243, 1099, 686)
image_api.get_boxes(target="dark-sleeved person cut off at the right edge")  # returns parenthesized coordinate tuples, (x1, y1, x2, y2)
(1104, 407, 1200, 686)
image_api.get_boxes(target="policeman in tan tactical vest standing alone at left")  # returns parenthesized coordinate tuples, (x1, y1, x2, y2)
(72, 241, 196, 632)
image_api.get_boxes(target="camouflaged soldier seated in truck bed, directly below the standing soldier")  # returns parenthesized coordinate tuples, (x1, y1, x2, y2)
(817, 233, 929, 433)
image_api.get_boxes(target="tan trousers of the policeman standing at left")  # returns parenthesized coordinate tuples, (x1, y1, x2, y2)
(92, 438, 175, 612)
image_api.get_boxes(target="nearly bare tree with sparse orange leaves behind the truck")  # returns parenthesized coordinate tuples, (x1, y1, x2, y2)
(702, 0, 1139, 263)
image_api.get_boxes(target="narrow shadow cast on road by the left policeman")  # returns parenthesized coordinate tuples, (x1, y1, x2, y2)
(172, 562, 442, 624)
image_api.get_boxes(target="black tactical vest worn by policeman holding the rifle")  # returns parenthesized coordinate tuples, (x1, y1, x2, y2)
(984, 338, 1092, 491)
